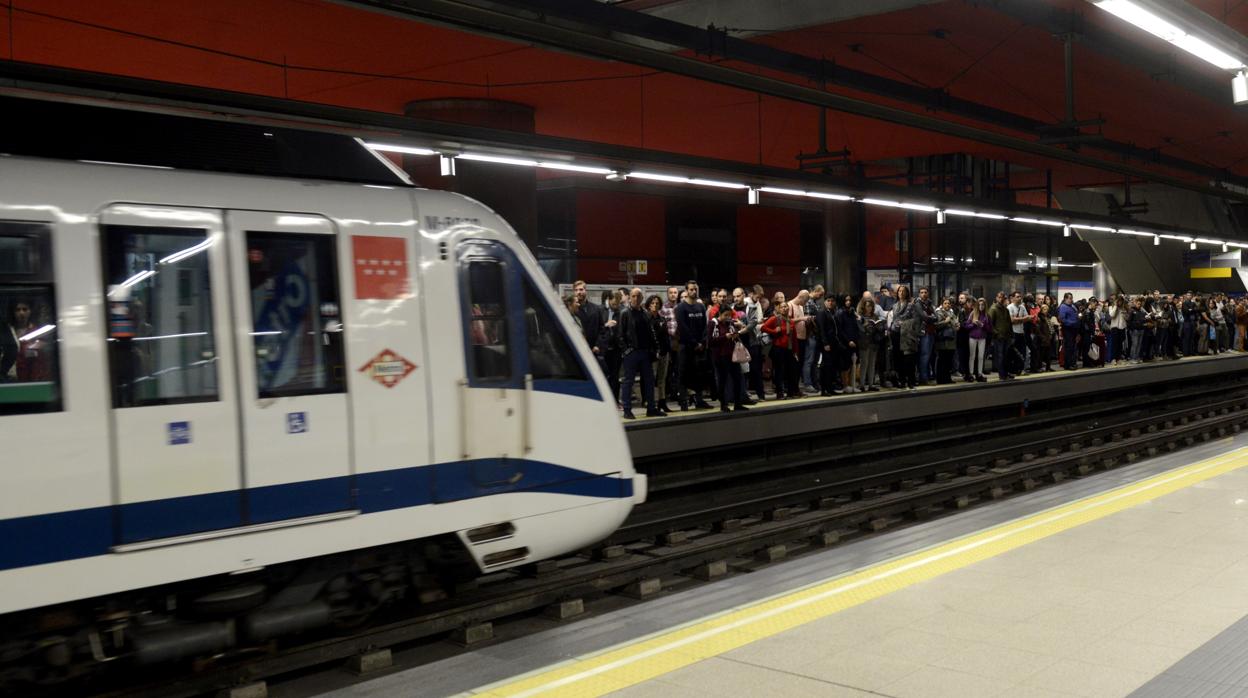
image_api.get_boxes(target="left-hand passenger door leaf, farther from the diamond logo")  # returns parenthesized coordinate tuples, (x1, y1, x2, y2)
(100, 205, 242, 543)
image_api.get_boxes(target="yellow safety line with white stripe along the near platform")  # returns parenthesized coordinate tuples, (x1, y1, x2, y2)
(472, 448, 1248, 698)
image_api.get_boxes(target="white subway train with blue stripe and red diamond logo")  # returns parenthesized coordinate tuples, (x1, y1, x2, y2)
(0, 156, 645, 686)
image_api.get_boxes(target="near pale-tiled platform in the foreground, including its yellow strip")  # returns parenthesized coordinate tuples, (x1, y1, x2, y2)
(321, 427, 1248, 698)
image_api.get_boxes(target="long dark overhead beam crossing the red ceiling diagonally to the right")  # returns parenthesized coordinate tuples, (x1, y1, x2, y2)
(341, 0, 1248, 202)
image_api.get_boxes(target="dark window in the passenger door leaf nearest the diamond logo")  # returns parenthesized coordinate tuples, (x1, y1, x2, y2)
(247, 231, 347, 397)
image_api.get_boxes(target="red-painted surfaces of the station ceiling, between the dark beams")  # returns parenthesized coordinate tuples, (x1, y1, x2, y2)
(0, 0, 1248, 191)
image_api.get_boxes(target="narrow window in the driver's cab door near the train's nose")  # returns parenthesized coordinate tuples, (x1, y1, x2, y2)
(468, 260, 512, 382)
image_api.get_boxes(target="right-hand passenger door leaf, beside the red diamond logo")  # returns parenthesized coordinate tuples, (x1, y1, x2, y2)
(227, 211, 352, 523)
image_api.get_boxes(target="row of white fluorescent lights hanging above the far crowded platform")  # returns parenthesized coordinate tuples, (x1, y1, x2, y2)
(364, 142, 1248, 248)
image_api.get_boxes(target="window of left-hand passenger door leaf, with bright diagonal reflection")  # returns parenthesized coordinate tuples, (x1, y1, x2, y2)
(100, 225, 218, 407)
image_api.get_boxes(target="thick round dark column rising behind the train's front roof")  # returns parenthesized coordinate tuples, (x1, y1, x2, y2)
(403, 99, 538, 247)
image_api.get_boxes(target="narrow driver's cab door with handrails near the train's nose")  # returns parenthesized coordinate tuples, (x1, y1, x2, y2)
(451, 240, 528, 474)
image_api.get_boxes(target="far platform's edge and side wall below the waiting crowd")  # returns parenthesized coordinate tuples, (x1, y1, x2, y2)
(625, 352, 1248, 461)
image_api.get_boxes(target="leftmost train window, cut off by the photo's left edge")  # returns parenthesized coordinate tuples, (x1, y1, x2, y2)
(0, 221, 61, 415)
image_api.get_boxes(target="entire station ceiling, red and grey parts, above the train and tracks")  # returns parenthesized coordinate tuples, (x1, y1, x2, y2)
(7, 0, 1248, 206)
